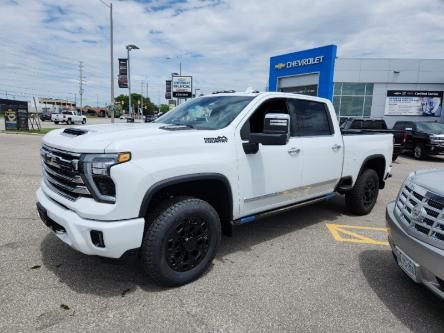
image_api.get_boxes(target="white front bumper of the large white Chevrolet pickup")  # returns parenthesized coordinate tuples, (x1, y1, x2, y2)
(37, 188, 145, 258)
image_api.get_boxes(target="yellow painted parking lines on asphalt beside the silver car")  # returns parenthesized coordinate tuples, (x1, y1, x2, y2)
(326, 223, 389, 245)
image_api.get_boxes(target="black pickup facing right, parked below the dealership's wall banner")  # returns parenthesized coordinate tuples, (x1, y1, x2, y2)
(393, 121, 444, 159)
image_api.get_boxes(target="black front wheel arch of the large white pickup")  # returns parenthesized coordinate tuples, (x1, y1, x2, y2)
(139, 173, 233, 236)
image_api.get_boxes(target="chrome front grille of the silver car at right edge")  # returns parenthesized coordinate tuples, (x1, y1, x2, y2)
(395, 183, 444, 249)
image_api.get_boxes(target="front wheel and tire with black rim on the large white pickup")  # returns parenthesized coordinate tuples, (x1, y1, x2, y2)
(140, 197, 221, 287)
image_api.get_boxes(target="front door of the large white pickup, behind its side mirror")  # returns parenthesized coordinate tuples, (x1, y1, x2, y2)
(237, 98, 302, 216)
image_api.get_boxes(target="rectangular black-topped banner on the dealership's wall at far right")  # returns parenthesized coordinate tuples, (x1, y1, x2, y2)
(384, 90, 443, 117)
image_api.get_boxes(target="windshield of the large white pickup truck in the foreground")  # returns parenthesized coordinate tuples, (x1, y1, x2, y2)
(155, 96, 255, 129)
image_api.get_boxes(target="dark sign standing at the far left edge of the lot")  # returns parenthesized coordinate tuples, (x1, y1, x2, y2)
(0, 99, 28, 130)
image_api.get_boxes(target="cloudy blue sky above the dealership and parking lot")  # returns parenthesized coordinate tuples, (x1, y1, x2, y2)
(0, 0, 444, 106)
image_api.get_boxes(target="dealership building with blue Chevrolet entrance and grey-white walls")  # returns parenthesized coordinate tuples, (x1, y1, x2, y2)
(268, 45, 444, 126)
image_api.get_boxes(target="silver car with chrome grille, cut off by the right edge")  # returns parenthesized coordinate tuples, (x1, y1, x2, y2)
(386, 169, 444, 299)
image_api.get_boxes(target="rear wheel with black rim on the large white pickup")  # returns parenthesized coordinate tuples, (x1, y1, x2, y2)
(345, 169, 380, 215)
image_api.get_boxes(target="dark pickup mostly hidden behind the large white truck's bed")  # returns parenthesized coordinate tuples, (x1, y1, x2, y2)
(341, 118, 404, 161)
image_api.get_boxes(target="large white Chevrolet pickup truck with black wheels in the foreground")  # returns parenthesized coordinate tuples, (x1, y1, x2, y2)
(37, 92, 393, 286)
